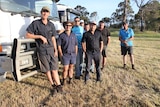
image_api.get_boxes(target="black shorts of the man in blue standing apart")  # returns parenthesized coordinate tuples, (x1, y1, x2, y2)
(121, 46, 133, 55)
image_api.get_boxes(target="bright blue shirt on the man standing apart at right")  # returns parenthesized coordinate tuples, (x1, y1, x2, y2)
(119, 28, 134, 46)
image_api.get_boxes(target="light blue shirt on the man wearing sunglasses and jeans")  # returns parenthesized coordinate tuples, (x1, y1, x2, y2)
(72, 26, 84, 48)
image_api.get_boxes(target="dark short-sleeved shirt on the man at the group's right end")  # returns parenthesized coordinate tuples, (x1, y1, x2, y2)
(98, 27, 111, 46)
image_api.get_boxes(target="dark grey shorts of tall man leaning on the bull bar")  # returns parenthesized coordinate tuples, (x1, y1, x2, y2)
(38, 55, 58, 72)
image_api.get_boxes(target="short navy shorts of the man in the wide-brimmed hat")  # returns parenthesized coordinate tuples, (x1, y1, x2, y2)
(62, 55, 76, 65)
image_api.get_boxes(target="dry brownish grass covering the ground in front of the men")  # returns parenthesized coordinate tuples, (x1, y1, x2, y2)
(0, 37, 160, 107)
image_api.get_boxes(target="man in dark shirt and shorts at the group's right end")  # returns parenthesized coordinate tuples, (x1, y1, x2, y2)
(98, 21, 110, 69)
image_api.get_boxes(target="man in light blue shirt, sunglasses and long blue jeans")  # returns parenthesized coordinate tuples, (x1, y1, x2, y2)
(72, 17, 84, 79)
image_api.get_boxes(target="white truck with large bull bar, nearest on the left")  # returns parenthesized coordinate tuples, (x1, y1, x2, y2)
(0, 0, 62, 81)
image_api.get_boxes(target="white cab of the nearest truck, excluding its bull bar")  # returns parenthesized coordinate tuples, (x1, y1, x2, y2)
(0, 0, 62, 55)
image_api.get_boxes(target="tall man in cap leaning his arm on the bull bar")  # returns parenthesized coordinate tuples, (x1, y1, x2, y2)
(26, 7, 62, 92)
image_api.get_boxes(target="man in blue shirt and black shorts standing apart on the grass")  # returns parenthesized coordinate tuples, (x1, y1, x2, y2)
(119, 22, 135, 69)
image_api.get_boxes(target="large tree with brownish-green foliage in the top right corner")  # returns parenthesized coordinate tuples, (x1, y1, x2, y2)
(135, 0, 160, 31)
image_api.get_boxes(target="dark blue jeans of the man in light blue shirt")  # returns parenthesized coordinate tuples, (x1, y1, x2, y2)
(75, 48, 83, 77)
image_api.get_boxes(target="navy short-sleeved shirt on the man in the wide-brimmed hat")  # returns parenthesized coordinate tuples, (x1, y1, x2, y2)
(57, 32, 78, 55)
